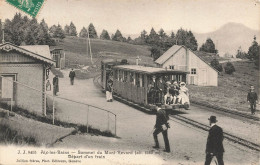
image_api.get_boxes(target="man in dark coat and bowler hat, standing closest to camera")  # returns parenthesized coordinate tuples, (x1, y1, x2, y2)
(205, 116, 224, 165)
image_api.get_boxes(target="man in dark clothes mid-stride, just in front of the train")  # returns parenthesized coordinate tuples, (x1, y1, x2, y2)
(153, 107, 171, 152)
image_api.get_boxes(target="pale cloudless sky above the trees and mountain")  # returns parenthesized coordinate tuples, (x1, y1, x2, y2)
(0, 0, 260, 35)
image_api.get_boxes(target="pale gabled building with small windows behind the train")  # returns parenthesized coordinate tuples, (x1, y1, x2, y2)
(155, 45, 218, 86)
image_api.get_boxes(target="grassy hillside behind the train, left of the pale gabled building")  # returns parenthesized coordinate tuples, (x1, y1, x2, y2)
(53, 37, 153, 65)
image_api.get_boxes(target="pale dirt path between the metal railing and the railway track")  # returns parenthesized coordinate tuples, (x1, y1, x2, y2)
(48, 71, 258, 164)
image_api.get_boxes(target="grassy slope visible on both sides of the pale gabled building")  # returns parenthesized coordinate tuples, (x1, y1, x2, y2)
(59, 37, 258, 111)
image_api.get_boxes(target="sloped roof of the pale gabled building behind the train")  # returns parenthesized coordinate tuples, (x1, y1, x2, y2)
(155, 45, 219, 72)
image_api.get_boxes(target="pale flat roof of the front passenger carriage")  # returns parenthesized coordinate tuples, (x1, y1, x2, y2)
(114, 65, 189, 74)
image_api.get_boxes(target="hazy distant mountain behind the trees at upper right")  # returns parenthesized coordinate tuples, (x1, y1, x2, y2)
(194, 23, 260, 56)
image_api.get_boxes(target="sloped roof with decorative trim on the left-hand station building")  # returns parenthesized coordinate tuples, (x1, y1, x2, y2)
(0, 42, 55, 65)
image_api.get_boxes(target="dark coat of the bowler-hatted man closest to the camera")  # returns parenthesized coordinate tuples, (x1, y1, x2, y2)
(206, 125, 225, 154)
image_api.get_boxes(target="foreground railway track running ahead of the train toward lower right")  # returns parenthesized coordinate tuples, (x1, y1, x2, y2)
(170, 115, 260, 151)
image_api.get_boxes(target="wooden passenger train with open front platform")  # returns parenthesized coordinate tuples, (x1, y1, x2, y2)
(101, 59, 189, 111)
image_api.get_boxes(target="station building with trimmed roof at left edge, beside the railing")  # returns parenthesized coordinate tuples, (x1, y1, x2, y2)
(0, 43, 55, 114)
